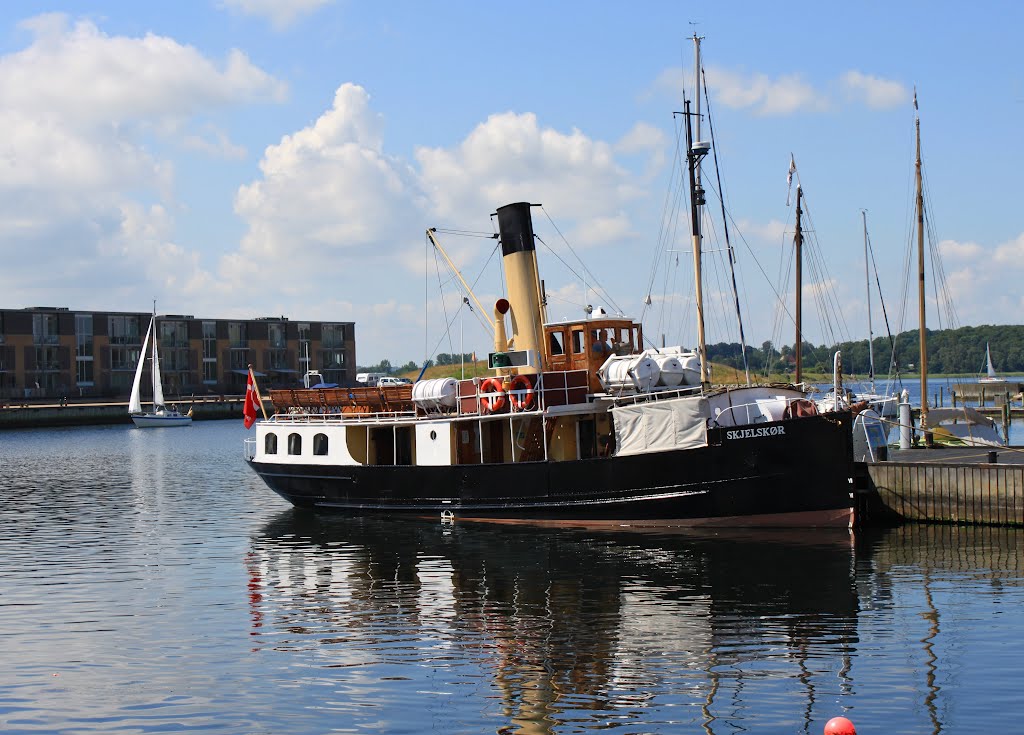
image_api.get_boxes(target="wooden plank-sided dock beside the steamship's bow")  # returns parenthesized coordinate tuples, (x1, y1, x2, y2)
(856, 446, 1024, 526)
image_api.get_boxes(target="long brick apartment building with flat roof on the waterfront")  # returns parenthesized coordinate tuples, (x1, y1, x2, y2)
(0, 306, 355, 398)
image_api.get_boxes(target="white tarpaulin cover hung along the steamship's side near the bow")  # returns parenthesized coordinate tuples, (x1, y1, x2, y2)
(611, 396, 711, 456)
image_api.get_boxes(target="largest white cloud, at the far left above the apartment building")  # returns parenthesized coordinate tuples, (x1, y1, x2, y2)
(0, 13, 286, 307)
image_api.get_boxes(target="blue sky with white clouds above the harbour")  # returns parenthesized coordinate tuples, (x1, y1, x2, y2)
(0, 0, 1024, 364)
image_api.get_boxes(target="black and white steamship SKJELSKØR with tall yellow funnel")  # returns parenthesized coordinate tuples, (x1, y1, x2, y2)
(246, 202, 853, 527)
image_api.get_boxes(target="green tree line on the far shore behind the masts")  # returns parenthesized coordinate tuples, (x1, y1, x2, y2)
(708, 325, 1024, 376)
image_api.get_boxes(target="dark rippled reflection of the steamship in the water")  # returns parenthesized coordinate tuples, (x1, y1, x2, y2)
(248, 512, 872, 733)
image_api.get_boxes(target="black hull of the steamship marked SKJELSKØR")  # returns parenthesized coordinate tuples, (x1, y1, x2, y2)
(250, 413, 853, 527)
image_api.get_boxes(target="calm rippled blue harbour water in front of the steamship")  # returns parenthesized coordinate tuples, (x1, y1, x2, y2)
(0, 421, 1024, 735)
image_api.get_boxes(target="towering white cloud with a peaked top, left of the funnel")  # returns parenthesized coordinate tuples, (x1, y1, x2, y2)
(221, 84, 426, 289)
